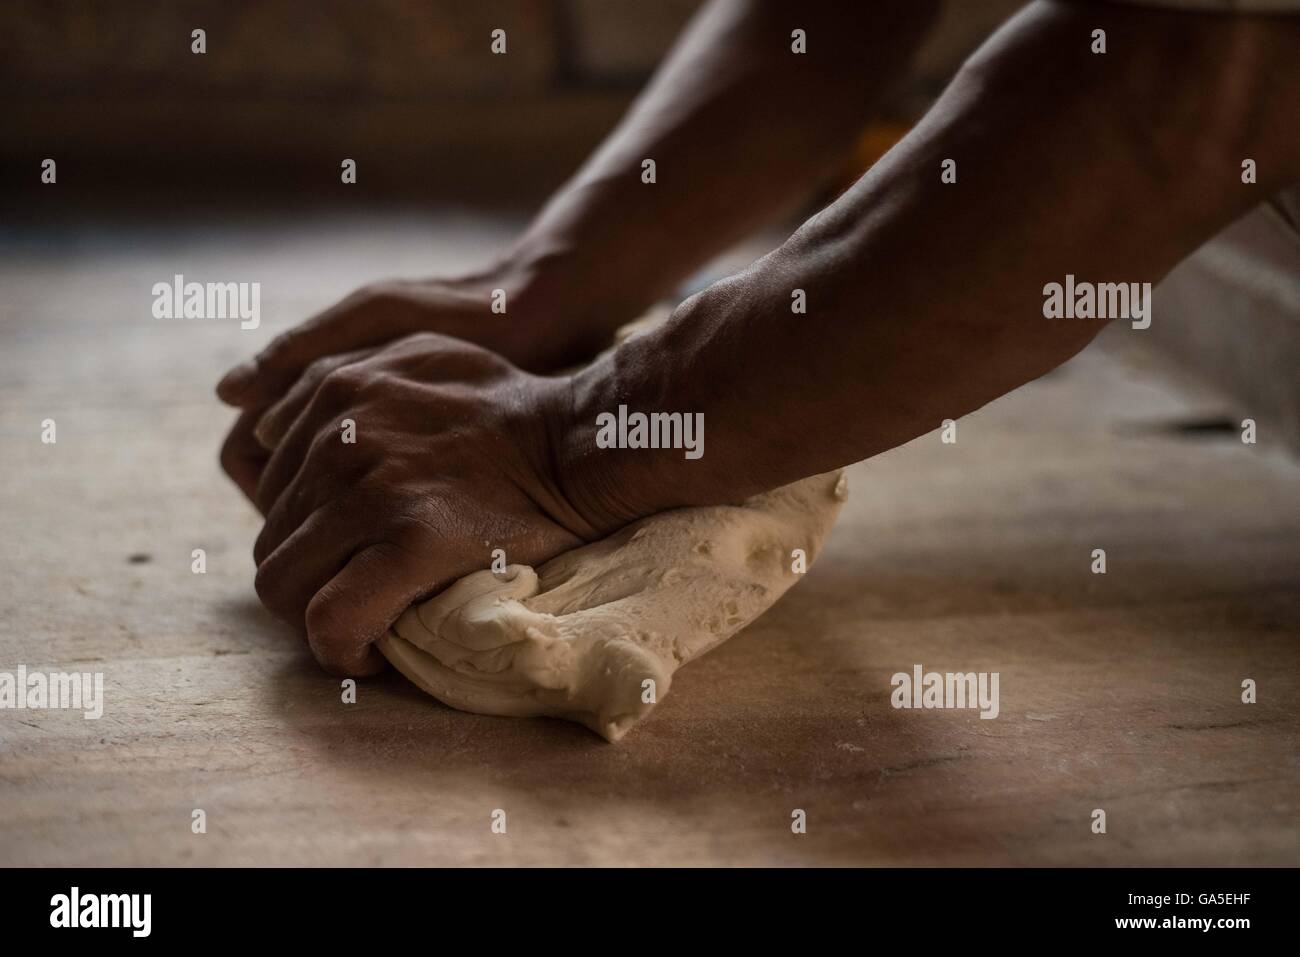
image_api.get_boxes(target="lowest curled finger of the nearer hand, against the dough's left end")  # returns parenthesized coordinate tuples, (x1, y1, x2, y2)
(307, 542, 446, 675)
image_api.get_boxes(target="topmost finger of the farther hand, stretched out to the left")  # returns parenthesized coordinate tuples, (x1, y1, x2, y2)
(217, 287, 420, 408)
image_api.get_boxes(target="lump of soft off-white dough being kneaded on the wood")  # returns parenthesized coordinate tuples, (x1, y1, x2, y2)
(378, 472, 846, 741)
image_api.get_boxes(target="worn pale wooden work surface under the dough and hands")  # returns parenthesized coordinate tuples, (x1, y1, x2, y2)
(0, 215, 1300, 865)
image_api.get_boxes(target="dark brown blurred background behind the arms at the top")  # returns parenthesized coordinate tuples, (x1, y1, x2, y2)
(0, 0, 1021, 205)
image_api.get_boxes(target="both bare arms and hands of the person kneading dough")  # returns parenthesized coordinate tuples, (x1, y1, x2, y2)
(220, 0, 1300, 674)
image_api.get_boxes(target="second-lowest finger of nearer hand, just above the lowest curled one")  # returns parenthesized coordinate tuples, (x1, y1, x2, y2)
(254, 502, 376, 632)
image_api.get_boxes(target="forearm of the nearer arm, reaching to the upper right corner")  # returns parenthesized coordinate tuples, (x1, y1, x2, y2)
(568, 4, 1300, 523)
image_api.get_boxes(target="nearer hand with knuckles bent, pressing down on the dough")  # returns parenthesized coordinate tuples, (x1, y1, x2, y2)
(246, 333, 612, 675)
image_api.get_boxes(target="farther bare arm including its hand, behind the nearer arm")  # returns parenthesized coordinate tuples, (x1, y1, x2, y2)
(218, 0, 937, 408)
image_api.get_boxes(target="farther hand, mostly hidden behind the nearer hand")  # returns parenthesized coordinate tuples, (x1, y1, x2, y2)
(217, 265, 616, 498)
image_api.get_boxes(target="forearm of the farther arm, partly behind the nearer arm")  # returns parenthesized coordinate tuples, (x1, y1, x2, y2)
(496, 0, 937, 343)
